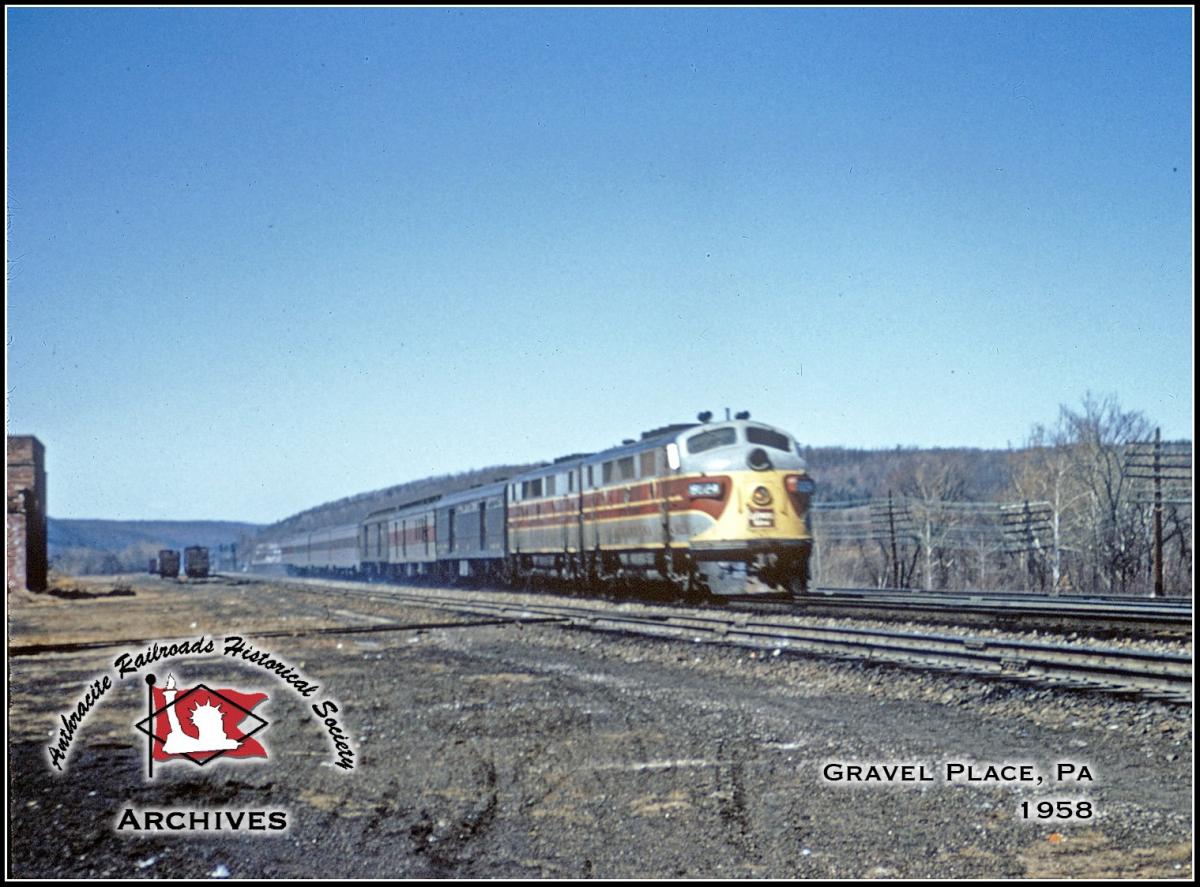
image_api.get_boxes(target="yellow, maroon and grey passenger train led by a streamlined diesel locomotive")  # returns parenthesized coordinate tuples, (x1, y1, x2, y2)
(280, 414, 814, 594)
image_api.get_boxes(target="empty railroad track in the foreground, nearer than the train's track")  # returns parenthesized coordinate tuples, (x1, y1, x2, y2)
(250, 579, 1192, 705)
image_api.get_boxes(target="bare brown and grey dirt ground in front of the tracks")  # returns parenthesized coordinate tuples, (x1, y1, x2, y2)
(8, 576, 1193, 879)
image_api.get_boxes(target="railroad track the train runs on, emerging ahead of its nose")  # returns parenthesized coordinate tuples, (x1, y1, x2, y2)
(732, 588, 1192, 637)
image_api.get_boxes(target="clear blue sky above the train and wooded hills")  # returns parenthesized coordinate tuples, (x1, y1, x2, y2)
(6, 8, 1193, 522)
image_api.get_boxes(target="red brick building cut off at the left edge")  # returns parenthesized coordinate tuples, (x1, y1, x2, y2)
(5, 434, 47, 592)
